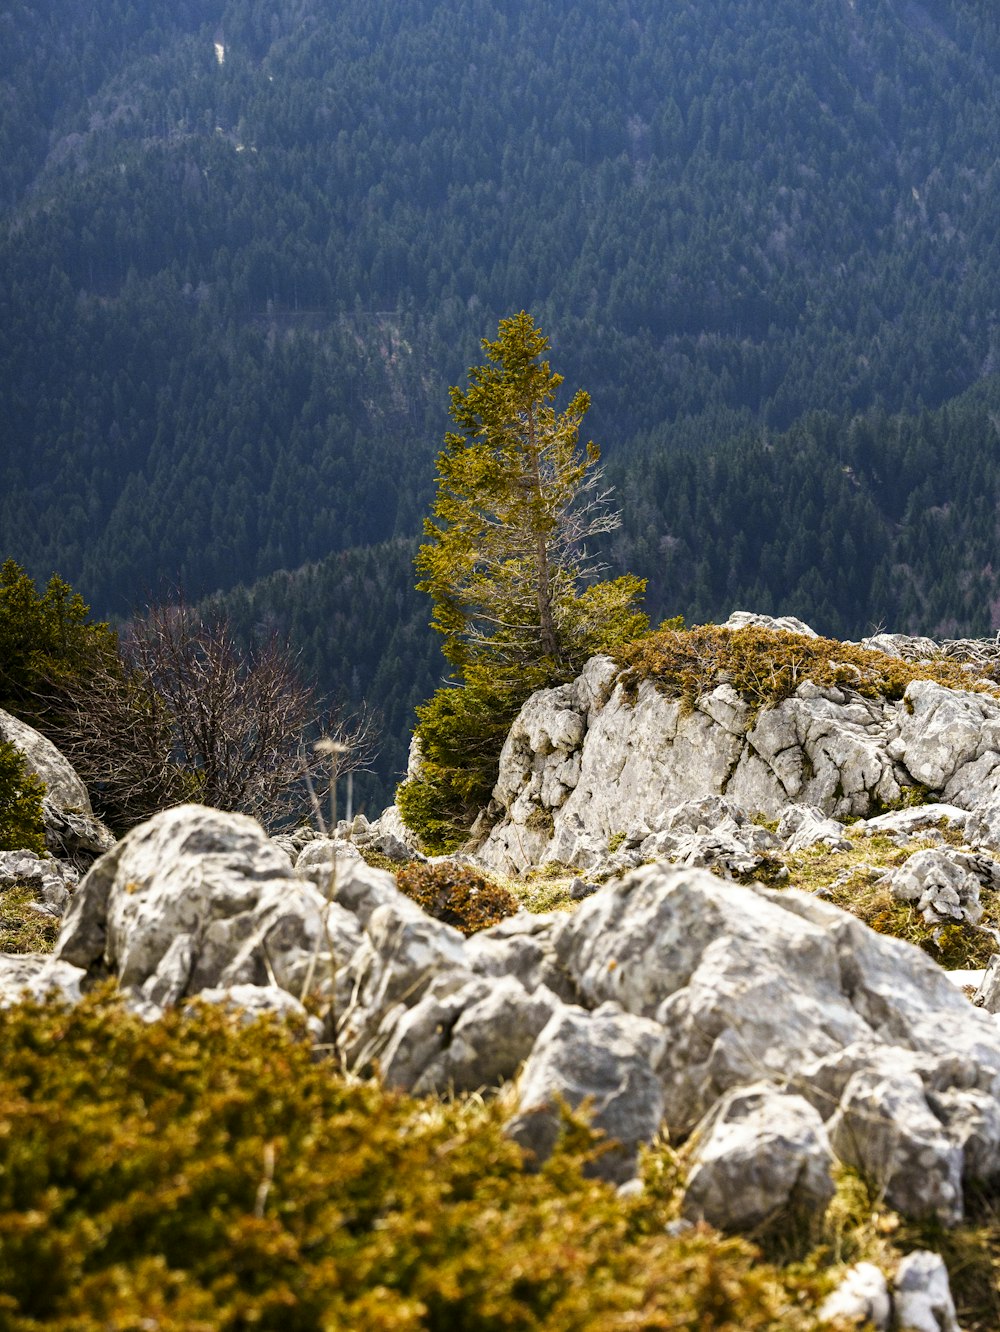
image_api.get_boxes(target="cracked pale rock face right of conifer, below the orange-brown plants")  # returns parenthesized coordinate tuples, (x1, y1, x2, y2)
(475, 617, 1000, 874)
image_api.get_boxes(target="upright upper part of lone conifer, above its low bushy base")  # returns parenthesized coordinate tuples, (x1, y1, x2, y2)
(417, 310, 644, 679)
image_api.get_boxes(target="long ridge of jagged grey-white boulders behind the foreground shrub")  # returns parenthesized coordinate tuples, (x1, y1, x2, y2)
(0, 806, 1000, 1228)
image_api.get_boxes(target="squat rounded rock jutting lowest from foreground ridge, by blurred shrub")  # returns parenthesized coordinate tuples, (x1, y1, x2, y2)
(683, 1083, 834, 1231)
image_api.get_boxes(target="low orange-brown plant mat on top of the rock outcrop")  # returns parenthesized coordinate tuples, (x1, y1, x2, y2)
(617, 625, 1000, 709)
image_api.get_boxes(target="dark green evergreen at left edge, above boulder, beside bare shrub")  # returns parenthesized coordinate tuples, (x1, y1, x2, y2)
(0, 559, 116, 729)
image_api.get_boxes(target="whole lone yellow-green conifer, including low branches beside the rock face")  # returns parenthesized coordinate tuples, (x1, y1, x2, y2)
(397, 310, 647, 850)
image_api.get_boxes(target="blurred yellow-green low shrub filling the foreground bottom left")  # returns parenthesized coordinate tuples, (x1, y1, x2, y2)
(0, 992, 818, 1332)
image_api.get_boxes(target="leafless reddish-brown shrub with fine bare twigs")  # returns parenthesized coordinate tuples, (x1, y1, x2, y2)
(60, 605, 373, 830)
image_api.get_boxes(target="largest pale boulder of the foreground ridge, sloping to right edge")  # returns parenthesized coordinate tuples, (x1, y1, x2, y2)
(540, 866, 1000, 1223)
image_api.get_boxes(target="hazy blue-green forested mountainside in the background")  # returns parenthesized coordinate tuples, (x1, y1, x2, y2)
(0, 0, 1000, 799)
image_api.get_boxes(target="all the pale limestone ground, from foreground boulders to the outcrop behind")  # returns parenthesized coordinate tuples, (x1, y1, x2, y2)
(0, 626, 1000, 1329)
